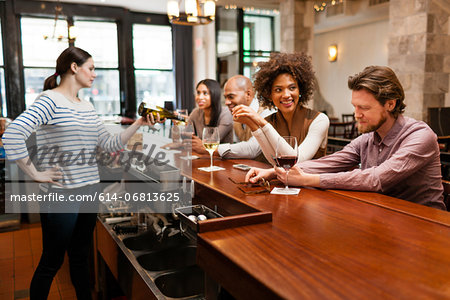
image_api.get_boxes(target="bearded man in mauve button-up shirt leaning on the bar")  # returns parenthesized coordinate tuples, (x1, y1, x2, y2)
(246, 66, 445, 210)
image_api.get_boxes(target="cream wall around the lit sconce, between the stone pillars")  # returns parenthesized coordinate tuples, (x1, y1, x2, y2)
(313, 20, 389, 118)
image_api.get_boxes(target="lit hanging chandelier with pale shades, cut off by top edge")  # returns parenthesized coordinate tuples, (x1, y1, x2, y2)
(167, 0, 216, 25)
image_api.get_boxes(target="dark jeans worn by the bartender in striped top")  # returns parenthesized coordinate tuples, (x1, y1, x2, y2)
(30, 186, 98, 300)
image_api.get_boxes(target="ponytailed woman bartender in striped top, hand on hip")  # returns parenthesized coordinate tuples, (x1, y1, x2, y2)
(3, 47, 154, 299)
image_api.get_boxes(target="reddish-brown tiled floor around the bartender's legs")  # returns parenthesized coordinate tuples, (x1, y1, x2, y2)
(0, 223, 76, 300)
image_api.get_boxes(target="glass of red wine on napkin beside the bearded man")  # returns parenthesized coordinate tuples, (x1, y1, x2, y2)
(275, 136, 298, 195)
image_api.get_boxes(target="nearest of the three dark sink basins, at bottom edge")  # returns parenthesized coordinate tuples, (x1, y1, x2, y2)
(155, 266, 205, 298)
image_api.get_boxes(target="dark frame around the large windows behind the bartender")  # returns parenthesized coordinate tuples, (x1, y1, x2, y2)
(0, 0, 177, 118)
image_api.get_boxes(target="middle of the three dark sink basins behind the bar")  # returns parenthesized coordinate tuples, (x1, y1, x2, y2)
(137, 245, 197, 272)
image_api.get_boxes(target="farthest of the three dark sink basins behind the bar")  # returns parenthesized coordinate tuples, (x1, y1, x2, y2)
(123, 231, 189, 251)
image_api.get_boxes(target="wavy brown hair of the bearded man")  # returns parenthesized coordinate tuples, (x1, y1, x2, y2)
(348, 66, 406, 119)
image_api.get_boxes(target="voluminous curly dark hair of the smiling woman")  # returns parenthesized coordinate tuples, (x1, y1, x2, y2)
(254, 53, 314, 108)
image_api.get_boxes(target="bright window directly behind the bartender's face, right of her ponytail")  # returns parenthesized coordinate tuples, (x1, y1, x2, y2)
(74, 20, 120, 115)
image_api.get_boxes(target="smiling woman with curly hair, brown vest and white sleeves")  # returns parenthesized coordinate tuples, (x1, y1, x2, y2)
(232, 53, 330, 165)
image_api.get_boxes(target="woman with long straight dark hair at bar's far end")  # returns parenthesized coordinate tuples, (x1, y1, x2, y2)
(189, 79, 233, 153)
